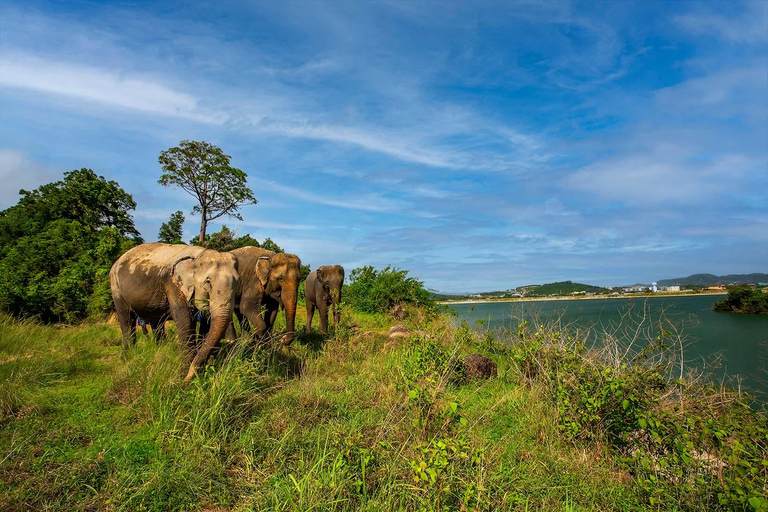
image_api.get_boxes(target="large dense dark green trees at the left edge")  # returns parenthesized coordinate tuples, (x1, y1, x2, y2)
(0, 169, 141, 322)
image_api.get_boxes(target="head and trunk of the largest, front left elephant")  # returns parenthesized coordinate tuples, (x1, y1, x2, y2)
(173, 249, 240, 381)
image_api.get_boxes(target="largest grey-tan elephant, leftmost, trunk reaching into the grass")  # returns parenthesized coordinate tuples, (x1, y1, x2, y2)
(109, 243, 240, 382)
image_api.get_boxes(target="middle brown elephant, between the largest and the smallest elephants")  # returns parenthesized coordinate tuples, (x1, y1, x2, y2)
(227, 247, 301, 345)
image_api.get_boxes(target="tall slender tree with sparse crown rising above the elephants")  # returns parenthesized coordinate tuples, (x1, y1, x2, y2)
(158, 140, 257, 244)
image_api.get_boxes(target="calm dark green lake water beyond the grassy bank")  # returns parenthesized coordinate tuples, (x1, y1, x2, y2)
(451, 295, 768, 400)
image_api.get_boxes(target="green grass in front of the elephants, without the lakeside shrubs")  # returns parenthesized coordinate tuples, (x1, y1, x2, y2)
(0, 311, 760, 511)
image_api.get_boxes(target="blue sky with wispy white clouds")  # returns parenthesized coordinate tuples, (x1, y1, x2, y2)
(0, 0, 768, 292)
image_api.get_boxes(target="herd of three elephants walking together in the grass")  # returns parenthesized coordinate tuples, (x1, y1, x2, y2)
(109, 243, 344, 382)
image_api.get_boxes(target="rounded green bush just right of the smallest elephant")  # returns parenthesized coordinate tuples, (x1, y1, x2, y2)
(343, 266, 435, 313)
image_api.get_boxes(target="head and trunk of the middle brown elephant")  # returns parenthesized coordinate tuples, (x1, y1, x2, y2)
(256, 253, 301, 345)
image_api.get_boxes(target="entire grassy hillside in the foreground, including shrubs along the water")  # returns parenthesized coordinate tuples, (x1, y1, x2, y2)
(0, 306, 768, 511)
